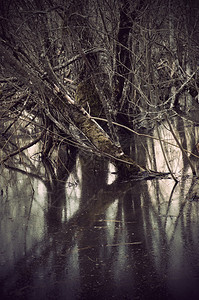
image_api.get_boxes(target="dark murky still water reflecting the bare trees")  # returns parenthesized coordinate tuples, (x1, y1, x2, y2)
(0, 116, 199, 300)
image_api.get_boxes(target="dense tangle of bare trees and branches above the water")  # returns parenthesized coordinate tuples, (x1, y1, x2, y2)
(0, 0, 199, 177)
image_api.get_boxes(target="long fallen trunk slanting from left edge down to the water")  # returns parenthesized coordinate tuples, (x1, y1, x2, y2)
(0, 48, 144, 173)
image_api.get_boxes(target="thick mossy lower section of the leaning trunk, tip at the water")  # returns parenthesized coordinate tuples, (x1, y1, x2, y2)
(46, 90, 145, 173)
